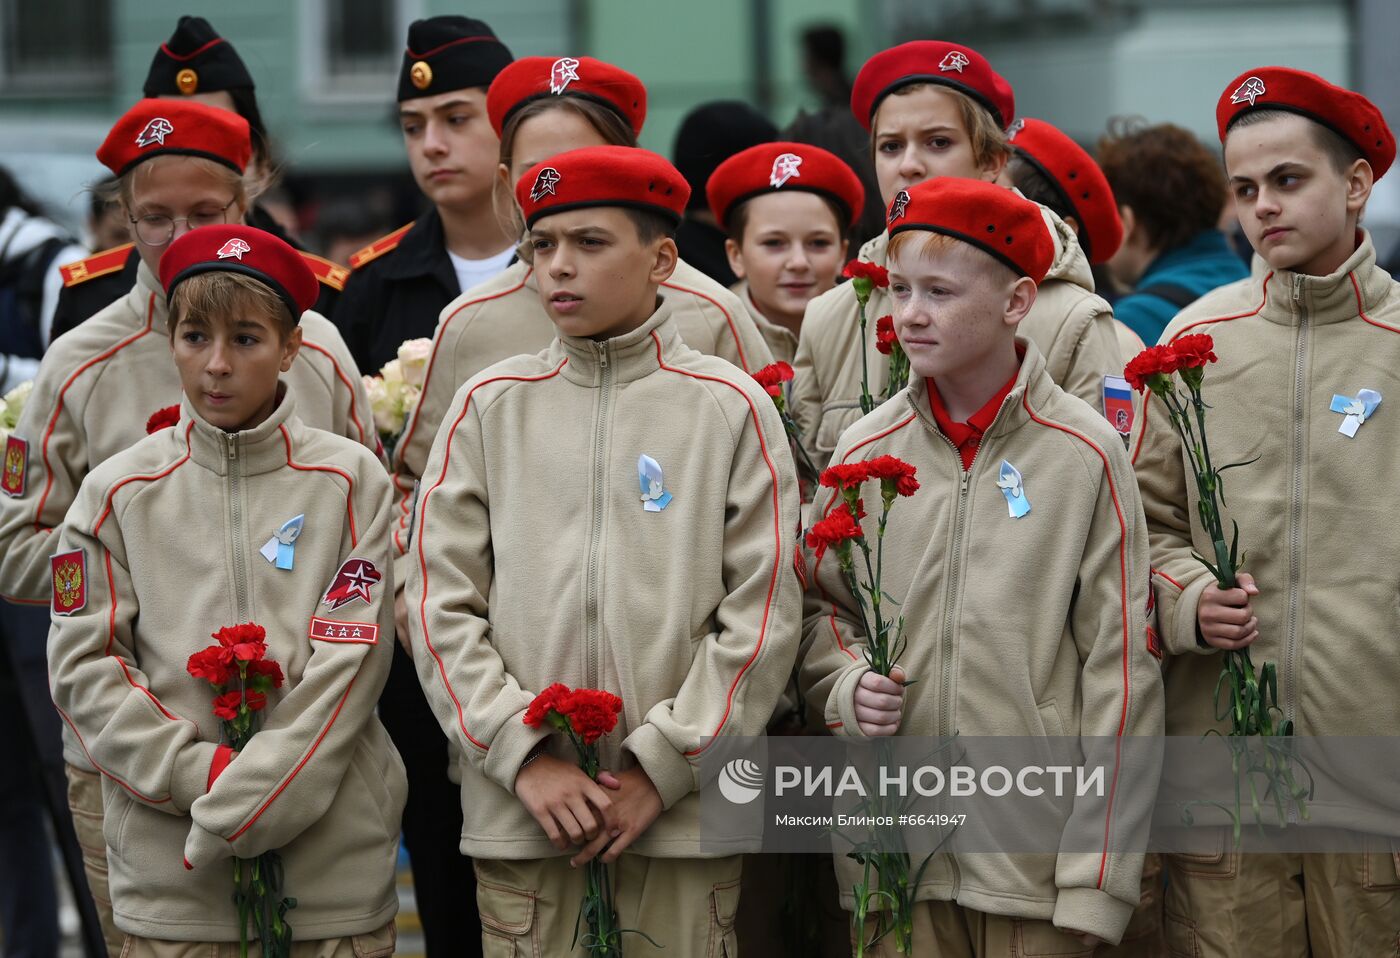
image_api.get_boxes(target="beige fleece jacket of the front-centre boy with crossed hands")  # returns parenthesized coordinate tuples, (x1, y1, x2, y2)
(406, 290, 801, 859)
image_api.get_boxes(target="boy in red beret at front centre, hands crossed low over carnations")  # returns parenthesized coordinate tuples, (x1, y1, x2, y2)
(406, 147, 801, 957)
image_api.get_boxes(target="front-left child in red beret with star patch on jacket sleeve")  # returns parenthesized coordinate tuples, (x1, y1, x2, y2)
(49, 226, 406, 958)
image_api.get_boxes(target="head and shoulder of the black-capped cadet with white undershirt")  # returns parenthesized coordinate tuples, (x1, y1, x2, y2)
(332, 17, 519, 375)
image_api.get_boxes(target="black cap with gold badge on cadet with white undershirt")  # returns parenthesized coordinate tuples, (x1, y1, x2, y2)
(399, 17, 514, 104)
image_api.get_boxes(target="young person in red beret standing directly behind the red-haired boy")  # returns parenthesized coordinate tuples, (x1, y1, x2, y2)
(792, 41, 1123, 465)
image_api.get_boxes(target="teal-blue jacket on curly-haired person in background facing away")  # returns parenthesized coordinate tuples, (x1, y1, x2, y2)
(1113, 230, 1249, 346)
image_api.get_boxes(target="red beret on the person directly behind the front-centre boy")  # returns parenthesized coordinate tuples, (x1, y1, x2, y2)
(486, 56, 647, 136)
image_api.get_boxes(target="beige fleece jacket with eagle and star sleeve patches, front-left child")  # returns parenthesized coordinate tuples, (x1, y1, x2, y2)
(49, 391, 407, 941)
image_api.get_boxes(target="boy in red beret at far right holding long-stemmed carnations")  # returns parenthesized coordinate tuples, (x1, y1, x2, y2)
(1133, 67, 1400, 958)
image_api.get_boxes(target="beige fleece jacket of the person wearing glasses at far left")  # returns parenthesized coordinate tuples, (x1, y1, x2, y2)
(0, 265, 378, 604)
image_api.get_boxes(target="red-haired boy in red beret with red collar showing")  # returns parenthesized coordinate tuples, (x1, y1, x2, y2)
(801, 176, 1162, 958)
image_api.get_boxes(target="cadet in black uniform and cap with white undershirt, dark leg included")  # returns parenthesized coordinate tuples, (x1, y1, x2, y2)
(332, 17, 517, 958)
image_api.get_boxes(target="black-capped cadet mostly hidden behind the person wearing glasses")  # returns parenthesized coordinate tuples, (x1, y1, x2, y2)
(50, 17, 349, 342)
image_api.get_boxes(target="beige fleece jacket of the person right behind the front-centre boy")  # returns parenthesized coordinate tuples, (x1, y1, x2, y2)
(392, 261, 773, 583)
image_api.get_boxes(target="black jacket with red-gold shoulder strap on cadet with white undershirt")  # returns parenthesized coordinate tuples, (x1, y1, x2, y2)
(330, 207, 462, 375)
